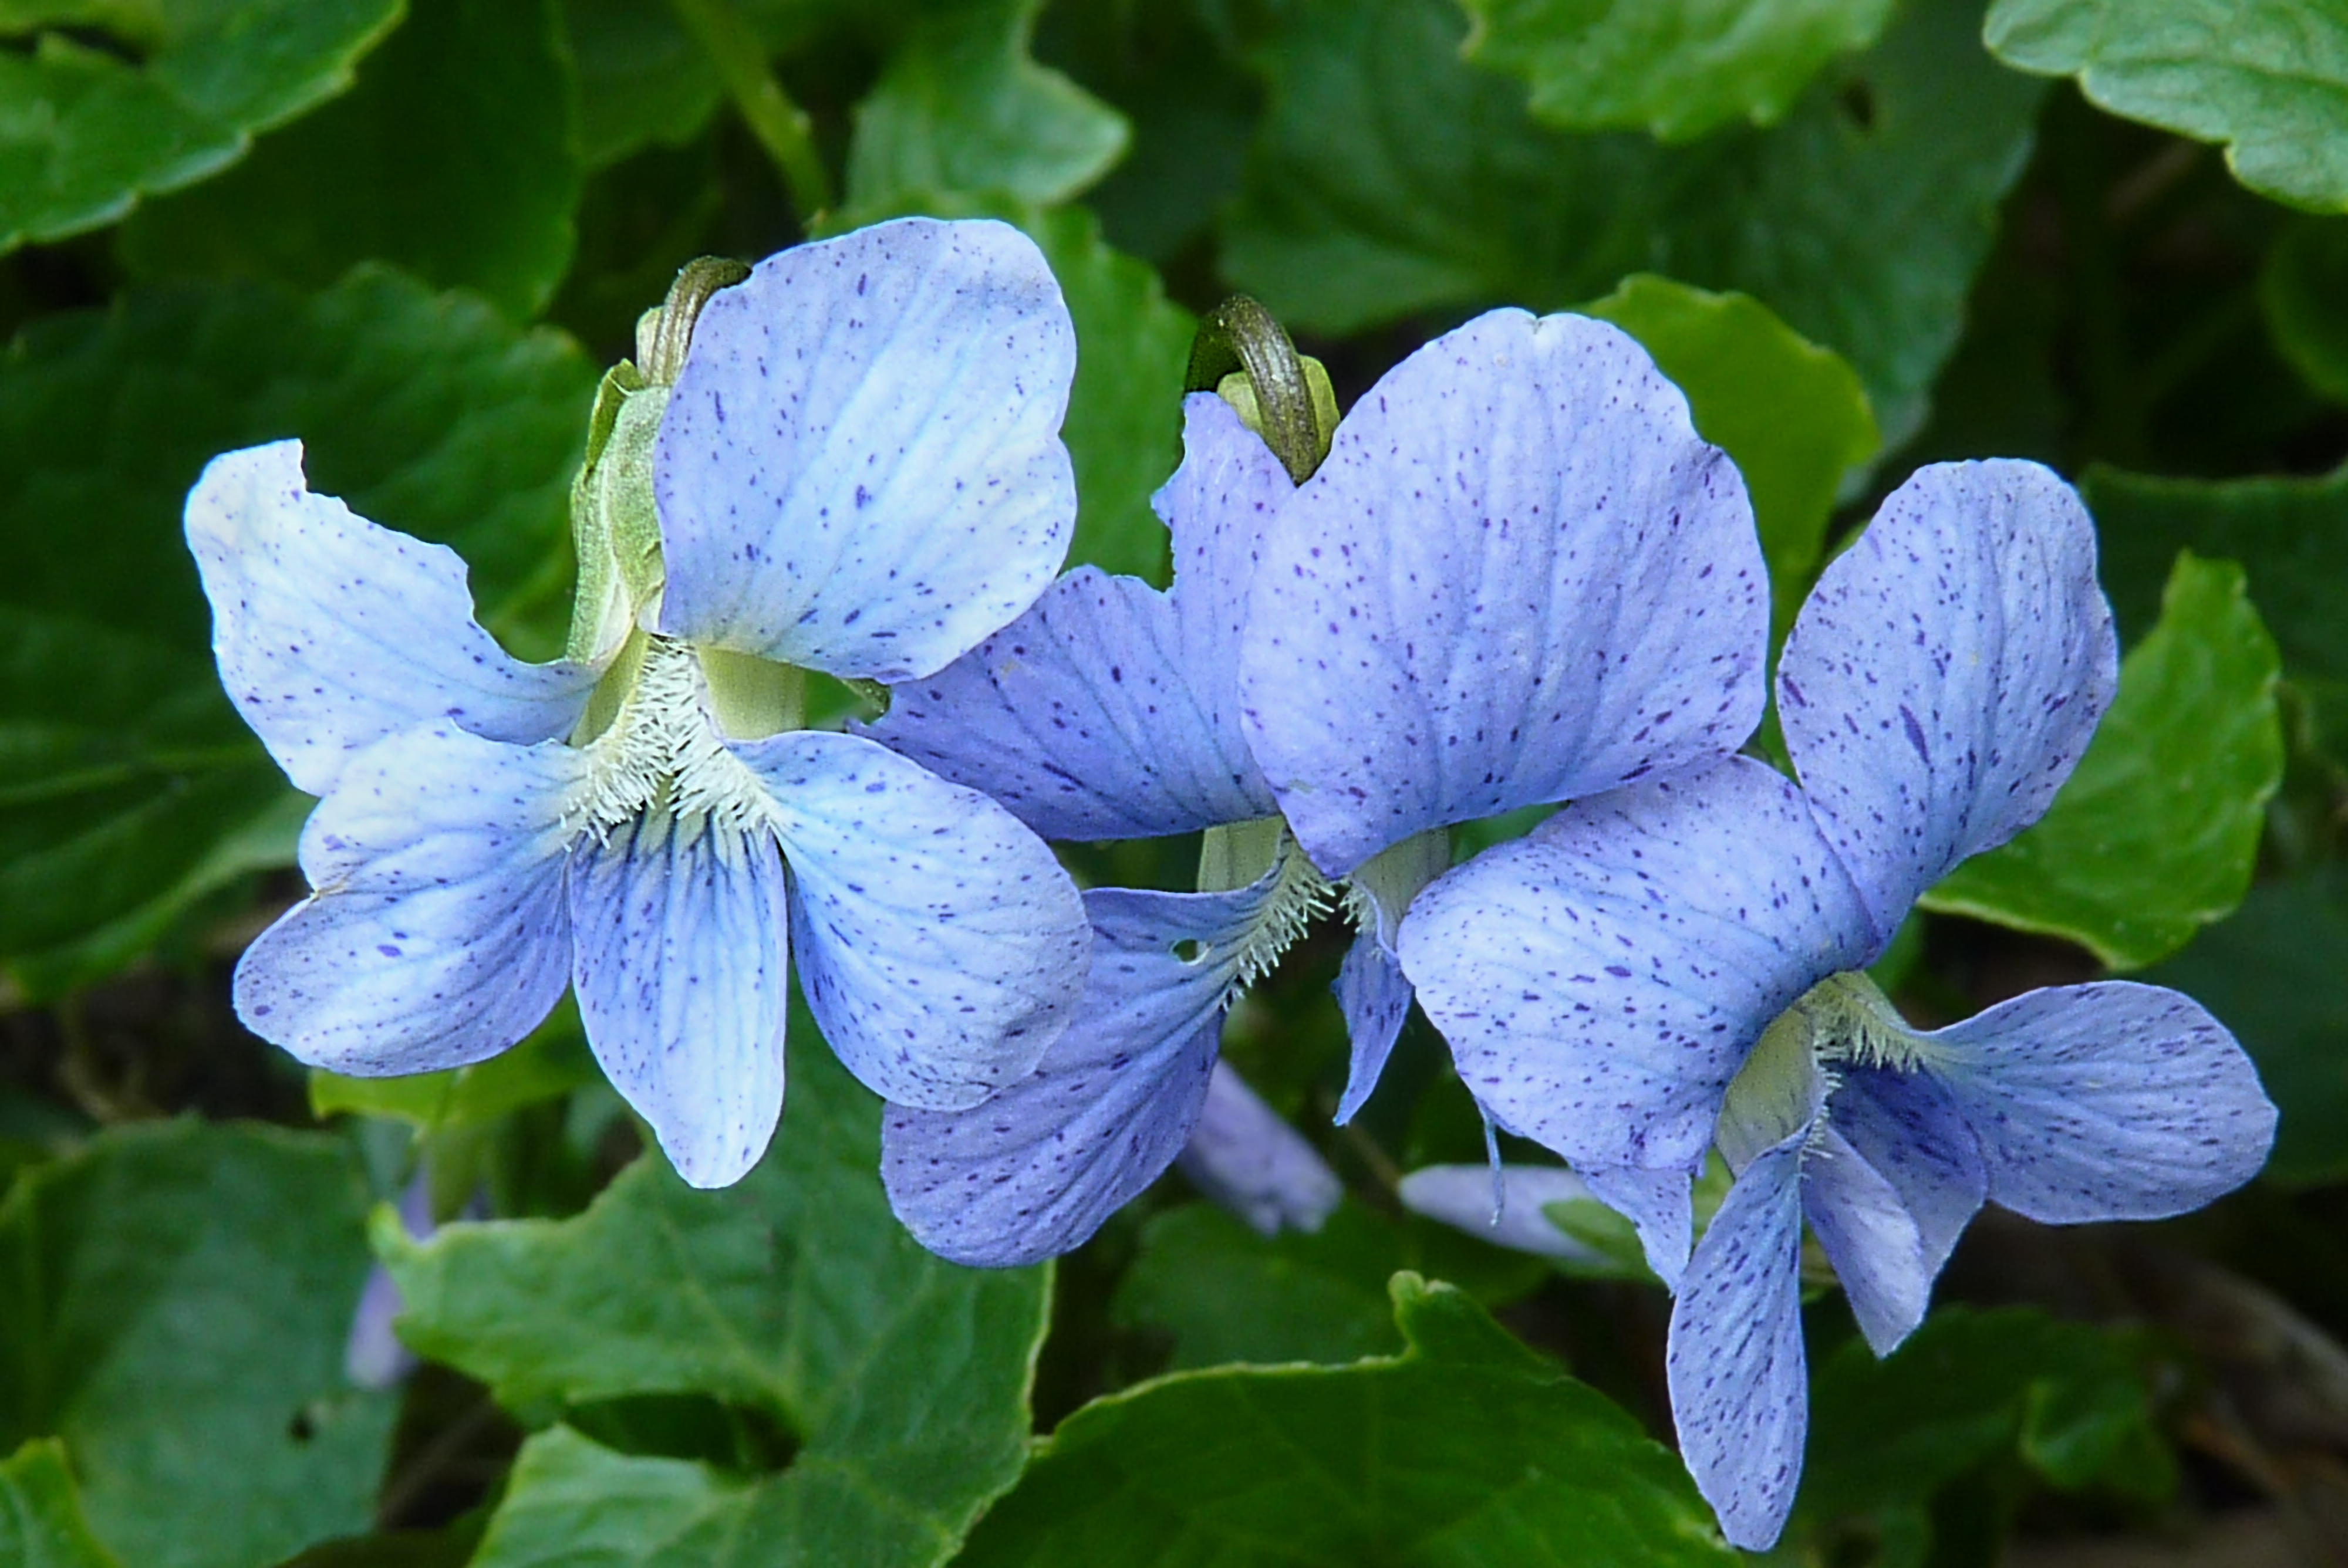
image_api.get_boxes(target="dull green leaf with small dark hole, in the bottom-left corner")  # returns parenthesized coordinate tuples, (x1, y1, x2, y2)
(0, 1122, 394, 1568)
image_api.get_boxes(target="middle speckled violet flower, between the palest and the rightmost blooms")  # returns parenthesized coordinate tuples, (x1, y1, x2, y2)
(871, 310, 1768, 1263)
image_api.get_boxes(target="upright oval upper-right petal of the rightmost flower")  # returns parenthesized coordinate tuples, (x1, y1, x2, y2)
(1777, 458, 2120, 941)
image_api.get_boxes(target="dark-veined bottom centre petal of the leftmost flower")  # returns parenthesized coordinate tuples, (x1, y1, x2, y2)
(571, 812, 791, 1188)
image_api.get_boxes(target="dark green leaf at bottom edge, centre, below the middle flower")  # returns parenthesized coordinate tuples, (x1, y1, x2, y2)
(958, 1275, 1738, 1568)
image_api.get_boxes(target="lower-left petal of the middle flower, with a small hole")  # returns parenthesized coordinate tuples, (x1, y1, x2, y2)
(880, 873, 1275, 1268)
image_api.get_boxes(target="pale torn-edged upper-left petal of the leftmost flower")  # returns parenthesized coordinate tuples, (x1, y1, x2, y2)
(185, 441, 596, 796)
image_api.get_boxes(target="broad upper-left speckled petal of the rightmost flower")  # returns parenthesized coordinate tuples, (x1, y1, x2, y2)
(1402, 758, 1874, 1171)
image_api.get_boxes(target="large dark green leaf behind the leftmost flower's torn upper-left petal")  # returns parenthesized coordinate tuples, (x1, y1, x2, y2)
(0, 257, 594, 995)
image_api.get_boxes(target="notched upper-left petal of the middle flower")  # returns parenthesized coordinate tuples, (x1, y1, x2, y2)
(866, 392, 1291, 838)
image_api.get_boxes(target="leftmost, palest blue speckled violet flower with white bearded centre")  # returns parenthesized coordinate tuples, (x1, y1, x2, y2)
(188, 221, 1089, 1185)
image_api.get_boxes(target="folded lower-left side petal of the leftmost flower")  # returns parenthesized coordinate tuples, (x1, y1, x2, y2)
(235, 723, 585, 1075)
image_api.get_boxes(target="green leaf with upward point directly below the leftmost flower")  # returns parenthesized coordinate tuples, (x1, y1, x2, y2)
(390, 1028, 1050, 1568)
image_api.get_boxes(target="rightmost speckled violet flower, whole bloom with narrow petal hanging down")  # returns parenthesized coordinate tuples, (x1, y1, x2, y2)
(1402, 462, 2275, 1549)
